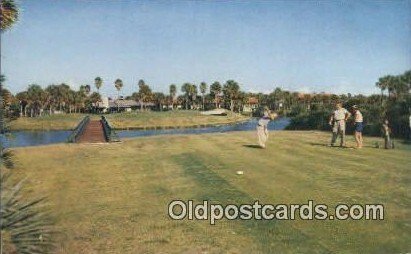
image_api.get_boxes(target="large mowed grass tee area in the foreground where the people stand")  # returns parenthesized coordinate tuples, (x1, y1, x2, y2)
(9, 131, 411, 253)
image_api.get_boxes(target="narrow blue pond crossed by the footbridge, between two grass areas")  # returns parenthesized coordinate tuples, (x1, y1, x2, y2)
(0, 118, 290, 147)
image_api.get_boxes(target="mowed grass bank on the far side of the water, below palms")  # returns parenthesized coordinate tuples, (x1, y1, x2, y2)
(10, 110, 247, 130)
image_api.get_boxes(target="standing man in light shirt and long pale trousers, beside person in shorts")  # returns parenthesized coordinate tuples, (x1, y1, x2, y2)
(329, 102, 350, 147)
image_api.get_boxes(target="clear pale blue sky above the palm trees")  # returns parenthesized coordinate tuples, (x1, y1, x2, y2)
(1, 0, 411, 96)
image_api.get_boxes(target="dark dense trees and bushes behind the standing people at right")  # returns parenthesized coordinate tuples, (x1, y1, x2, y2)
(288, 71, 411, 138)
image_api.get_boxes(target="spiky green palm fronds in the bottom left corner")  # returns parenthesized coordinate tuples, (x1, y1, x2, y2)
(0, 172, 54, 253)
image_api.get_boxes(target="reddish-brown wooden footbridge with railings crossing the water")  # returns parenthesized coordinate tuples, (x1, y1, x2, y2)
(68, 116, 120, 143)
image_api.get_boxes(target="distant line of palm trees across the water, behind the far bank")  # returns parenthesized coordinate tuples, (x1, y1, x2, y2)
(1, 76, 338, 117)
